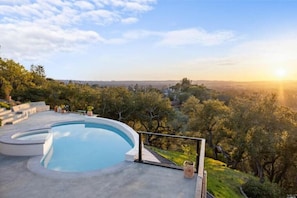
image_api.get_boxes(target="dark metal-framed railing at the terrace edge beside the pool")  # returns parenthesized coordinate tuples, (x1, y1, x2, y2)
(135, 131, 207, 198)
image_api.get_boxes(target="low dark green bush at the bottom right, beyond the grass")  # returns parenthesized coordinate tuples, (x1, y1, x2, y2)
(242, 179, 282, 198)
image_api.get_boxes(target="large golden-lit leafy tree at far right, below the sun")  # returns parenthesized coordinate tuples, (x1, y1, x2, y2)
(225, 95, 296, 187)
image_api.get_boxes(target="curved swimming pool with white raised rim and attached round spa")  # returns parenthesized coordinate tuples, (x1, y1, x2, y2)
(0, 116, 139, 172)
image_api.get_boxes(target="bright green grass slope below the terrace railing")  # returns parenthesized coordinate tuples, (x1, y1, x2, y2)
(151, 148, 253, 198)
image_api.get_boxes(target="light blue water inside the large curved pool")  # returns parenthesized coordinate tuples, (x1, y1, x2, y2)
(43, 123, 133, 172)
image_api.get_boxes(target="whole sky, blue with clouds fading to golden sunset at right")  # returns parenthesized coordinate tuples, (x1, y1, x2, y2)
(0, 0, 297, 81)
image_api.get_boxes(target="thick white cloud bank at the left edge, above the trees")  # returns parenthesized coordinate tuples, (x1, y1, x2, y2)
(0, 22, 104, 61)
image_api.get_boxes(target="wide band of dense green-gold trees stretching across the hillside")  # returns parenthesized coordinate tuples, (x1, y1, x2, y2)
(0, 58, 297, 193)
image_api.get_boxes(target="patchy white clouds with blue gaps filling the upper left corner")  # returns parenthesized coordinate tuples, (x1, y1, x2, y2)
(0, 0, 155, 60)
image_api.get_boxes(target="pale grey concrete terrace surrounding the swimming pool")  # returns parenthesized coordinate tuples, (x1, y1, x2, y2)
(0, 111, 197, 198)
